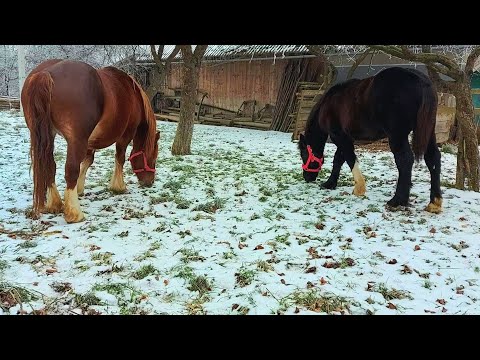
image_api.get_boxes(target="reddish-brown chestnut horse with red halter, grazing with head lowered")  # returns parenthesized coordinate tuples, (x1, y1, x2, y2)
(21, 60, 160, 223)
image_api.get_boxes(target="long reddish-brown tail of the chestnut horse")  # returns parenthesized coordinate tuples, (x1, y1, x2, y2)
(22, 71, 55, 217)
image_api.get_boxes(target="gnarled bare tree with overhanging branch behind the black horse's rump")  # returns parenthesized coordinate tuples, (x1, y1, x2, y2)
(370, 45, 480, 191)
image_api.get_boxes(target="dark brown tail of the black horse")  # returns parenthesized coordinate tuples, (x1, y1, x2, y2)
(412, 86, 438, 161)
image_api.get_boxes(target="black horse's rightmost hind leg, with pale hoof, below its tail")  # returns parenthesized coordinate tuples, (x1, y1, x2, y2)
(424, 133, 442, 214)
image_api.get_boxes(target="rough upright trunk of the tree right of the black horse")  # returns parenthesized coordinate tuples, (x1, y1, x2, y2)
(455, 77, 480, 191)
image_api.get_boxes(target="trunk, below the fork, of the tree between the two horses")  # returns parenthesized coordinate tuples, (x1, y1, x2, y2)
(172, 59, 200, 155)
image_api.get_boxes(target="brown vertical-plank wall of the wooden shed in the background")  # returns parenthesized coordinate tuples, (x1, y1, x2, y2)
(167, 59, 288, 111)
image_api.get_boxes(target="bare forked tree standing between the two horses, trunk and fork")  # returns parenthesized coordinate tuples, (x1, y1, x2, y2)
(172, 45, 208, 155)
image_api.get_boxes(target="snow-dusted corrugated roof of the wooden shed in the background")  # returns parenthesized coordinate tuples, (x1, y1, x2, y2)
(138, 45, 310, 61)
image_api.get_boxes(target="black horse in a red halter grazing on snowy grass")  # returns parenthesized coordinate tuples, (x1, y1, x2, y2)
(298, 67, 442, 213)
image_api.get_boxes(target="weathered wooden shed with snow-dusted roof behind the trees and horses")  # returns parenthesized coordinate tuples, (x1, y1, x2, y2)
(128, 45, 472, 141)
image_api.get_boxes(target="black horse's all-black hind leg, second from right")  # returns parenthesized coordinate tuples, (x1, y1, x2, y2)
(387, 136, 414, 207)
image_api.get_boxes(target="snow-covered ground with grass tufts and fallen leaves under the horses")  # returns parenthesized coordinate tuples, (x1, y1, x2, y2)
(0, 113, 480, 314)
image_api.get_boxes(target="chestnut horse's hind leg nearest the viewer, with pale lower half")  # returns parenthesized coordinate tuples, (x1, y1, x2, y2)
(64, 140, 87, 223)
